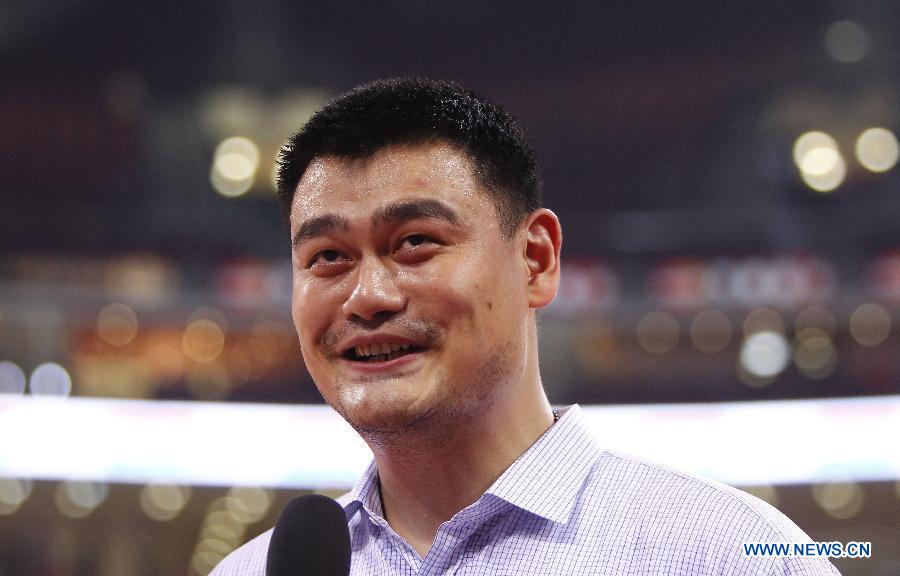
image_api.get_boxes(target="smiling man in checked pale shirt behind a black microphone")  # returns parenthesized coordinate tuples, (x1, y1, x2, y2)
(213, 79, 837, 576)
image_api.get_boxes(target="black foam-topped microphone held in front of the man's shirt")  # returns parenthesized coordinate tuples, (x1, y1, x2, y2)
(266, 494, 350, 576)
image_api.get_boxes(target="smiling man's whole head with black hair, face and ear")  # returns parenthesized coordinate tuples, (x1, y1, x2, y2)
(280, 80, 561, 446)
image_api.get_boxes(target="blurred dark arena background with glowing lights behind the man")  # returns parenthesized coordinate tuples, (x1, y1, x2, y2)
(0, 0, 900, 576)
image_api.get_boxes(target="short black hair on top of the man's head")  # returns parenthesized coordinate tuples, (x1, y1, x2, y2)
(278, 77, 542, 238)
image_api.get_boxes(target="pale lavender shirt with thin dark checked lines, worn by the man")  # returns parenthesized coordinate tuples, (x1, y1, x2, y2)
(212, 406, 838, 576)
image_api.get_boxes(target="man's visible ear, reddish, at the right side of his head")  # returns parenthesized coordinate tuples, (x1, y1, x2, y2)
(524, 208, 562, 308)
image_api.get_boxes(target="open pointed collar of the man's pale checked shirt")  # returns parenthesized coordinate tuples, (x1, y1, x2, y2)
(338, 404, 602, 522)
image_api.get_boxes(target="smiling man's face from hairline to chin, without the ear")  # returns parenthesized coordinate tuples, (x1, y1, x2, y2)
(290, 143, 529, 433)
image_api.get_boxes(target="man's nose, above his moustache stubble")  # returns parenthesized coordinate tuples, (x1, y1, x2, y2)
(343, 258, 406, 321)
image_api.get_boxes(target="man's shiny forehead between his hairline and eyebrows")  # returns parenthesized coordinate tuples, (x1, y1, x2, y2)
(291, 143, 493, 228)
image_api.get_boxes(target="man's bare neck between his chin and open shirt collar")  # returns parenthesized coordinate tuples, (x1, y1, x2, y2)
(369, 342, 553, 557)
